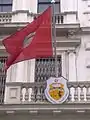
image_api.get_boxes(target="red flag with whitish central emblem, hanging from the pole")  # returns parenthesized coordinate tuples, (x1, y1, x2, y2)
(3, 7, 53, 69)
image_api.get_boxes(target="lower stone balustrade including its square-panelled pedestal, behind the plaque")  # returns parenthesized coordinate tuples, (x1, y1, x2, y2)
(0, 75, 90, 104)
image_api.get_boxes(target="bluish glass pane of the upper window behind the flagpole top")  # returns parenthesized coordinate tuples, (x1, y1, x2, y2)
(38, 4, 60, 13)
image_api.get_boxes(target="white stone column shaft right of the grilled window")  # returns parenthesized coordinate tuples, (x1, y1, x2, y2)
(69, 51, 77, 81)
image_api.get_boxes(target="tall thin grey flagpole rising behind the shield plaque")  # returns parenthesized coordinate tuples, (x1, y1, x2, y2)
(51, 0, 58, 77)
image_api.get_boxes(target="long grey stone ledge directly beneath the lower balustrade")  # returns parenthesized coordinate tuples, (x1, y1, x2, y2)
(0, 103, 90, 112)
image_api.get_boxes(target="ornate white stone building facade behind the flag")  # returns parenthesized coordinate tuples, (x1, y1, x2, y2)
(0, 0, 90, 120)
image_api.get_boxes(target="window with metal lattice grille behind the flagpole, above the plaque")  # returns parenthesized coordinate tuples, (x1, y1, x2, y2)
(35, 56, 62, 82)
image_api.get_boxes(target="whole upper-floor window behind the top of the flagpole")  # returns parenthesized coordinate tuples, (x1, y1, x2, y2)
(38, 0, 60, 13)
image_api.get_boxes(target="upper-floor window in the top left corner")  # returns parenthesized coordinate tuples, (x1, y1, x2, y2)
(0, 0, 12, 12)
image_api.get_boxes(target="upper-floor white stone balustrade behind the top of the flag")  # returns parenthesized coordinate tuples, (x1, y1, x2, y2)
(0, 11, 77, 24)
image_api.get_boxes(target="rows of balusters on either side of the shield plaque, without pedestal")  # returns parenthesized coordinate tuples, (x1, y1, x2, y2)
(20, 82, 90, 104)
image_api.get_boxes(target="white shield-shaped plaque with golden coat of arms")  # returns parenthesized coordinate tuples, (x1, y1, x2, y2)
(45, 77, 69, 104)
